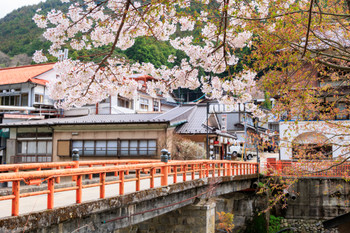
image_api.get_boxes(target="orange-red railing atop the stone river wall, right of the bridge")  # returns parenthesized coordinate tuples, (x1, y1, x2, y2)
(260, 160, 350, 178)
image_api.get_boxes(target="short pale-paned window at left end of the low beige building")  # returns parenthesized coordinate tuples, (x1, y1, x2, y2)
(17, 140, 52, 155)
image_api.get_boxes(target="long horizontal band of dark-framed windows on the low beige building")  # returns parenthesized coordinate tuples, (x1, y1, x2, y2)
(72, 139, 157, 156)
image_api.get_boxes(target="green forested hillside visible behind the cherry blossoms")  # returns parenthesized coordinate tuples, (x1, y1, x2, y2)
(0, 0, 184, 67)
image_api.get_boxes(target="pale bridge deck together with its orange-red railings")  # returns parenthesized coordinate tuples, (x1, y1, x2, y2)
(0, 160, 257, 218)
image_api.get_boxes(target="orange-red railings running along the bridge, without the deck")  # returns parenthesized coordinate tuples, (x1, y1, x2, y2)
(0, 160, 257, 216)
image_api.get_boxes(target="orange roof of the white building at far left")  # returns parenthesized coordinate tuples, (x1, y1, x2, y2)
(0, 63, 54, 85)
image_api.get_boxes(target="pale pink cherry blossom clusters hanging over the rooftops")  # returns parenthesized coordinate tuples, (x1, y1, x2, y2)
(33, 0, 268, 117)
